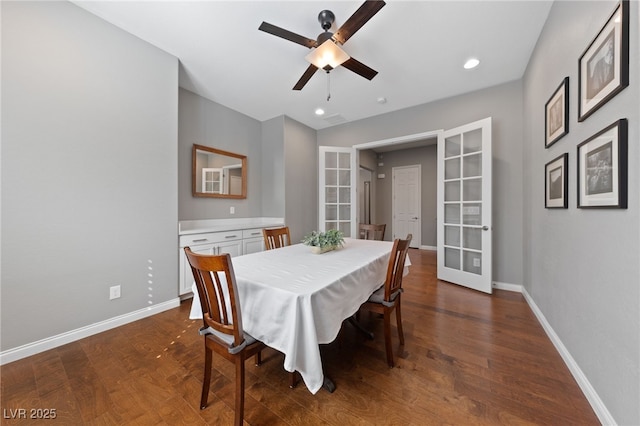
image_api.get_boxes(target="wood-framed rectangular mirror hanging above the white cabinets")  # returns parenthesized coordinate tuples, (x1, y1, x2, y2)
(191, 144, 247, 198)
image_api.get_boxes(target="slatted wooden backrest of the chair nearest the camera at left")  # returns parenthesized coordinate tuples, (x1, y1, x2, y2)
(184, 247, 244, 346)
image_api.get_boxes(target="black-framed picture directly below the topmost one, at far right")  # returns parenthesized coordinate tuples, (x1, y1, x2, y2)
(578, 119, 627, 209)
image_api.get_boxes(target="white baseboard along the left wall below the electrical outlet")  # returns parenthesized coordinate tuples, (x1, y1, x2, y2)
(0, 298, 180, 365)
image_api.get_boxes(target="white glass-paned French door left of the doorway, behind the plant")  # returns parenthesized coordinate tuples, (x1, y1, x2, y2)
(318, 146, 357, 238)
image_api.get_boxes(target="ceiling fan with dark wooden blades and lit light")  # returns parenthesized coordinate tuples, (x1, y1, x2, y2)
(258, 0, 386, 90)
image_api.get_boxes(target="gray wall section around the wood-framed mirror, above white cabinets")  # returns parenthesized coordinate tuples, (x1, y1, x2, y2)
(178, 89, 263, 220)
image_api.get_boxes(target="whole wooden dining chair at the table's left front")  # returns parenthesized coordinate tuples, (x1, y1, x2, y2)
(184, 247, 265, 426)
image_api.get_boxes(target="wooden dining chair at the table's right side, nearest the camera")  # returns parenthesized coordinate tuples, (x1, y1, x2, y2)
(363, 234, 412, 367)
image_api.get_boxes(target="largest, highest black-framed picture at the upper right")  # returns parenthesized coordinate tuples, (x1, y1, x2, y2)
(578, 0, 629, 121)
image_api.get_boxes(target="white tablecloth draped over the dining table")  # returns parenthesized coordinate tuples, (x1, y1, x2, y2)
(190, 239, 411, 394)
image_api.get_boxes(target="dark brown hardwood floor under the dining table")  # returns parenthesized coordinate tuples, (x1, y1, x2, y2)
(0, 250, 599, 426)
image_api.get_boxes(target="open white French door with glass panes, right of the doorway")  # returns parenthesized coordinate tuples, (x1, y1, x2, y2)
(437, 117, 492, 293)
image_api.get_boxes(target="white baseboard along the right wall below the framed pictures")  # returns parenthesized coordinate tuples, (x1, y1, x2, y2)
(522, 287, 616, 425)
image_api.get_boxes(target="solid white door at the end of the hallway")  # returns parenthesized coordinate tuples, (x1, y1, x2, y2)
(392, 164, 422, 248)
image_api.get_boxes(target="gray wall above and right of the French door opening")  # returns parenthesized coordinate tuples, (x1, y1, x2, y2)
(318, 81, 523, 284)
